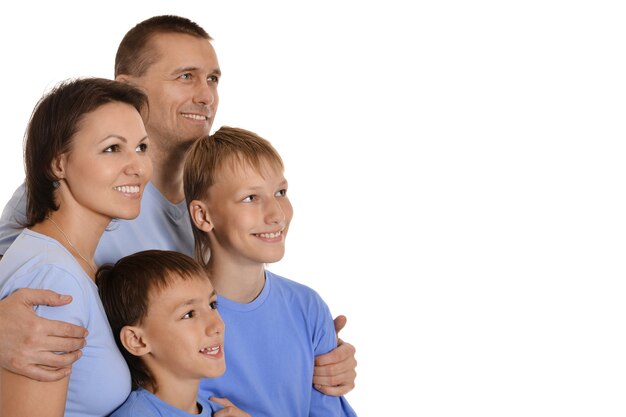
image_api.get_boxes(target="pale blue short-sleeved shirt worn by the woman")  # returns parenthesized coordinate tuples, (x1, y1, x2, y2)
(0, 229, 131, 417)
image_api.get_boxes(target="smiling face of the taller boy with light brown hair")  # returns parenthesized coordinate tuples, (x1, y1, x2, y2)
(205, 158, 293, 264)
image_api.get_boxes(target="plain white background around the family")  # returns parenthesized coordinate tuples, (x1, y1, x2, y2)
(0, 0, 626, 417)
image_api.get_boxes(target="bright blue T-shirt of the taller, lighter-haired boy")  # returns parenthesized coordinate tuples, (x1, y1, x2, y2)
(200, 271, 356, 417)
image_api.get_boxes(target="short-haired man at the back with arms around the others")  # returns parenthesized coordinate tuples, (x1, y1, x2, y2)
(0, 16, 356, 395)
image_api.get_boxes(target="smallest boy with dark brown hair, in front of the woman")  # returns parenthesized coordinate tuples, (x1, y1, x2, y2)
(96, 250, 249, 417)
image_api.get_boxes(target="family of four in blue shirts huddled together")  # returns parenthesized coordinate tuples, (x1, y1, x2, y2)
(0, 15, 356, 417)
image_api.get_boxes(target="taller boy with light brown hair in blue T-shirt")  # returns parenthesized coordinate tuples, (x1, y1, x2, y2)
(183, 127, 356, 417)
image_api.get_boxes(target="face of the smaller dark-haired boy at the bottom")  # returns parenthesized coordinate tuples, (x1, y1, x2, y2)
(140, 276, 226, 384)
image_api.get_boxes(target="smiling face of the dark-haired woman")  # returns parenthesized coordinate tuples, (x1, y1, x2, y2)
(58, 102, 152, 219)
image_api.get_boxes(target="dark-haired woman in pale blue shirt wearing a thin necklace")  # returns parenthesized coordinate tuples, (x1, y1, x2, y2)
(0, 78, 152, 417)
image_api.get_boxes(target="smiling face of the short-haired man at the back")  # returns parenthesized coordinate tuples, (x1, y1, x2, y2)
(124, 33, 221, 151)
